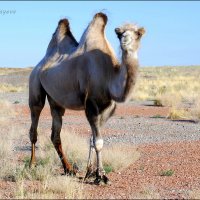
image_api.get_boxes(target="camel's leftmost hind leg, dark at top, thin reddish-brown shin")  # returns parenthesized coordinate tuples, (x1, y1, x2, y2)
(29, 87, 46, 167)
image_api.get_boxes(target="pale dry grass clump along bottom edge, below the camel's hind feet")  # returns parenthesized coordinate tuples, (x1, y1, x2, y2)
(15, 175, 87, 199)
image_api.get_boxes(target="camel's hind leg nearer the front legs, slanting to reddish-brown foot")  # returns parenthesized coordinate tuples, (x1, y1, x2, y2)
(47, 96, 77, 174)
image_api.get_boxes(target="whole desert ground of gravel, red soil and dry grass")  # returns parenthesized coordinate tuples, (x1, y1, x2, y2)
(0, 66, 200, 199)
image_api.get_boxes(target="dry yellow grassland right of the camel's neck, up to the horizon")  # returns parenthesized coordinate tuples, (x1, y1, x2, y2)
(132, 66, 200, 120)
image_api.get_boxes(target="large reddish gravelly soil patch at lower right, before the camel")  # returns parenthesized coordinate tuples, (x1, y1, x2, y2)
(85, 141, 200, 199)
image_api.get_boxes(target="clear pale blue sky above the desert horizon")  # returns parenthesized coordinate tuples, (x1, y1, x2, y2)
(0, 1, 200, 67)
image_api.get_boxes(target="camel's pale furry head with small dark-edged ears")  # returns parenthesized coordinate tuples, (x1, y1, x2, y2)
(115, 24, 145, 52)
